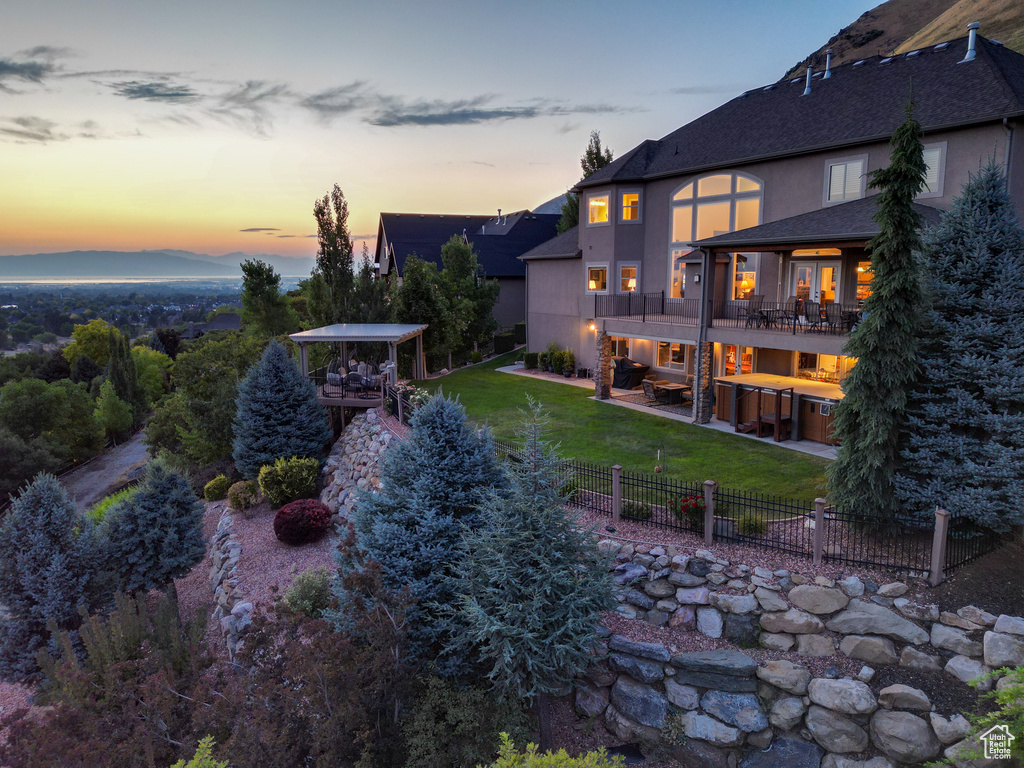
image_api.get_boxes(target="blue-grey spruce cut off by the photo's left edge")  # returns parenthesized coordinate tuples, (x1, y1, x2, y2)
(0, 473, 100, 680)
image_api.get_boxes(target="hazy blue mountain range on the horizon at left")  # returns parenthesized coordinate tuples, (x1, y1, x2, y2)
(0, 249, 315, 279)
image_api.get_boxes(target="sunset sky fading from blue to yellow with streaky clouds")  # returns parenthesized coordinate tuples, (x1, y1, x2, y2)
(0, 0, 876, 256)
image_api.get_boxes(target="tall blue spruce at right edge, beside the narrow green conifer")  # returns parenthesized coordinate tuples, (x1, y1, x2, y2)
(896, 163, 1024, 530)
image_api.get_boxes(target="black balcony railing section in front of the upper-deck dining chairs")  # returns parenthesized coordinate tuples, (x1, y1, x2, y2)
(709, 300, 863, 336)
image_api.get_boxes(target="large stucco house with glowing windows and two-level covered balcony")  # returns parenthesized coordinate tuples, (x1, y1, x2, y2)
(522, 28, 1024, 441)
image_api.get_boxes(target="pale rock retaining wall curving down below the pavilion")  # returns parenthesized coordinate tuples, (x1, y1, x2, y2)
(321, 410, 397, 517)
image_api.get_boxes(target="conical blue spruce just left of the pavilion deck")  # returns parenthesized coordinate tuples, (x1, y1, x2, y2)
(232, 341, 331, 478)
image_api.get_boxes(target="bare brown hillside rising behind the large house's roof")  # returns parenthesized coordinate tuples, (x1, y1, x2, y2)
(783, 0, 1024, 79)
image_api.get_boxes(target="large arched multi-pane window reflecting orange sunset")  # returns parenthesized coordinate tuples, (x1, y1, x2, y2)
(669, 173, 764, 298)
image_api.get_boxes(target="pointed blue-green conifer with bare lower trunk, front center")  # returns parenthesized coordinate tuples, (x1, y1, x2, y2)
(452, 402, 612, 750)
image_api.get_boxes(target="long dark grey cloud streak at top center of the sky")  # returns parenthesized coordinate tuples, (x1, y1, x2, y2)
(365, 94, 627, 128)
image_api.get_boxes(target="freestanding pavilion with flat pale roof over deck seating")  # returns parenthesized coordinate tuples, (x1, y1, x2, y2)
(289, 323, 427, 409)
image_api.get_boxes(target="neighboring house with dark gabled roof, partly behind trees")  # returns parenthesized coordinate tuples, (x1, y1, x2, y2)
(375, 210, 560, 328)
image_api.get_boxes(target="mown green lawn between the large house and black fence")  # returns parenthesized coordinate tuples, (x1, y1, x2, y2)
(420, 352, 828, 500)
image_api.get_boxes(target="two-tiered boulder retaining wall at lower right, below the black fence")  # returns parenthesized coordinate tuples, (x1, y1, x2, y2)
(593, 540, 1024, 768)
